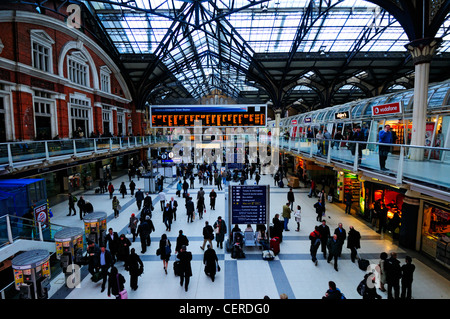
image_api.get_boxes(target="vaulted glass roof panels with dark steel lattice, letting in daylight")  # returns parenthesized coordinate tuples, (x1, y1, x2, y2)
(84, 0, 450, 102)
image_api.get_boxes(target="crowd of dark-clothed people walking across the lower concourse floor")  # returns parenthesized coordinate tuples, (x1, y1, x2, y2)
(65, 160, 414, 299)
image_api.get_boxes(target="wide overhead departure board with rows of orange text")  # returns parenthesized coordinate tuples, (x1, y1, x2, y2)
(150, 104, 267, 127)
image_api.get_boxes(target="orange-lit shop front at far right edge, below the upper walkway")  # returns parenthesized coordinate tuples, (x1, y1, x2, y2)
(421, 201, 450, 268)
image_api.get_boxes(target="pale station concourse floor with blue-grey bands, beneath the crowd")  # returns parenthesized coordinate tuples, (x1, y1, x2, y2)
(45, 175, 450, 300)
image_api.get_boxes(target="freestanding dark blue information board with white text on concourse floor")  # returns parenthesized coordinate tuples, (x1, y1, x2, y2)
(230, 185, 268, 224)
